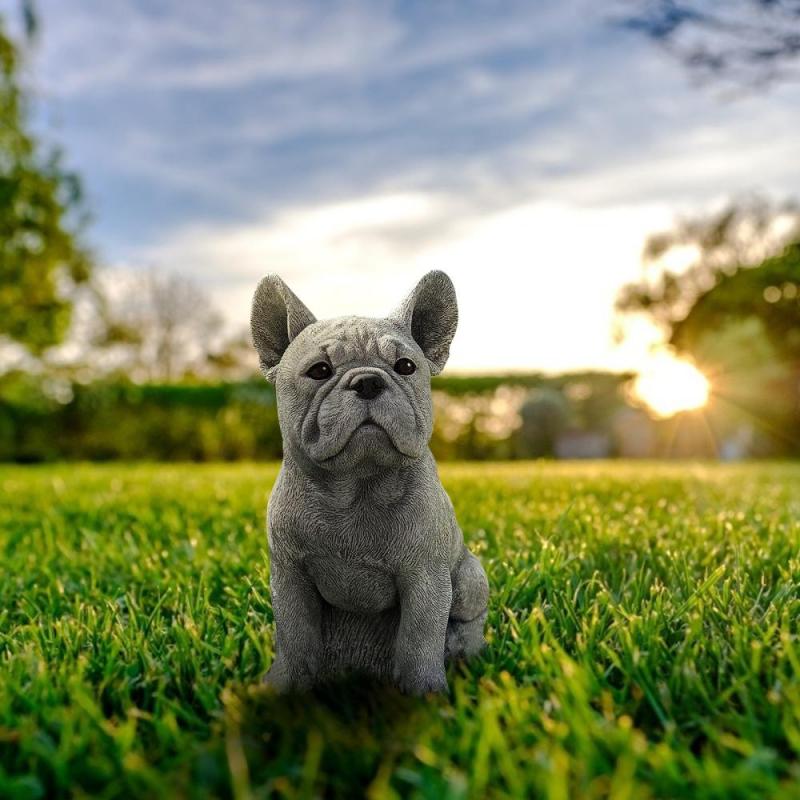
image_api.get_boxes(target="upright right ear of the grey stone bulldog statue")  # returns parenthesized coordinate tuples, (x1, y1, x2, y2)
(389, 270, 458, 375)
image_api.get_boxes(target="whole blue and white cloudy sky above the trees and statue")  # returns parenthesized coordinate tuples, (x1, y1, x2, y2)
(10, 0, 800, 372)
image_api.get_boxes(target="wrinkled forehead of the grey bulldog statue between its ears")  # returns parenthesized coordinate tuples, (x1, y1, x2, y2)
(301, 317, 416, 364)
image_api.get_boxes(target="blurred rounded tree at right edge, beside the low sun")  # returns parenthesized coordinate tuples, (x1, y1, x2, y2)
(617, 202, 800, 453)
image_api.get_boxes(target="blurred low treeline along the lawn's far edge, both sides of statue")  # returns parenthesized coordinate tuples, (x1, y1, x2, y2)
(0, 372, 788, 463)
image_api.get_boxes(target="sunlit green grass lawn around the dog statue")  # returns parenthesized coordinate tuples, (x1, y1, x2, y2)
(0, 463, 800, 800)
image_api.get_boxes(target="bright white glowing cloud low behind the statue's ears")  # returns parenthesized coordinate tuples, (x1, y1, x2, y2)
(125, 188, 668, 371)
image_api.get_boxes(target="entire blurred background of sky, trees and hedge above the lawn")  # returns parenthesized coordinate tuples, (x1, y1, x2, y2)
(0, 0, 800, 462)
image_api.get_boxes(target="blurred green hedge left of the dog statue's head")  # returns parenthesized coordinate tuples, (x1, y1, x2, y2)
(0, 378, 281, 462)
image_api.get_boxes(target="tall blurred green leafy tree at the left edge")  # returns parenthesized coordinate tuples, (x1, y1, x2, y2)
(0, 12, 91, 355)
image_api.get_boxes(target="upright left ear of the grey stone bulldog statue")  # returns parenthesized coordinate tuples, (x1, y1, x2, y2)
(250, 275, 317, 381)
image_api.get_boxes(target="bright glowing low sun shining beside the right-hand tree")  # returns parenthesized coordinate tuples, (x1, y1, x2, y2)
(633, 353, 711, 417)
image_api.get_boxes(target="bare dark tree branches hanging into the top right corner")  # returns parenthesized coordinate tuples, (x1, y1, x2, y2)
(622, 0, 800, 85)
